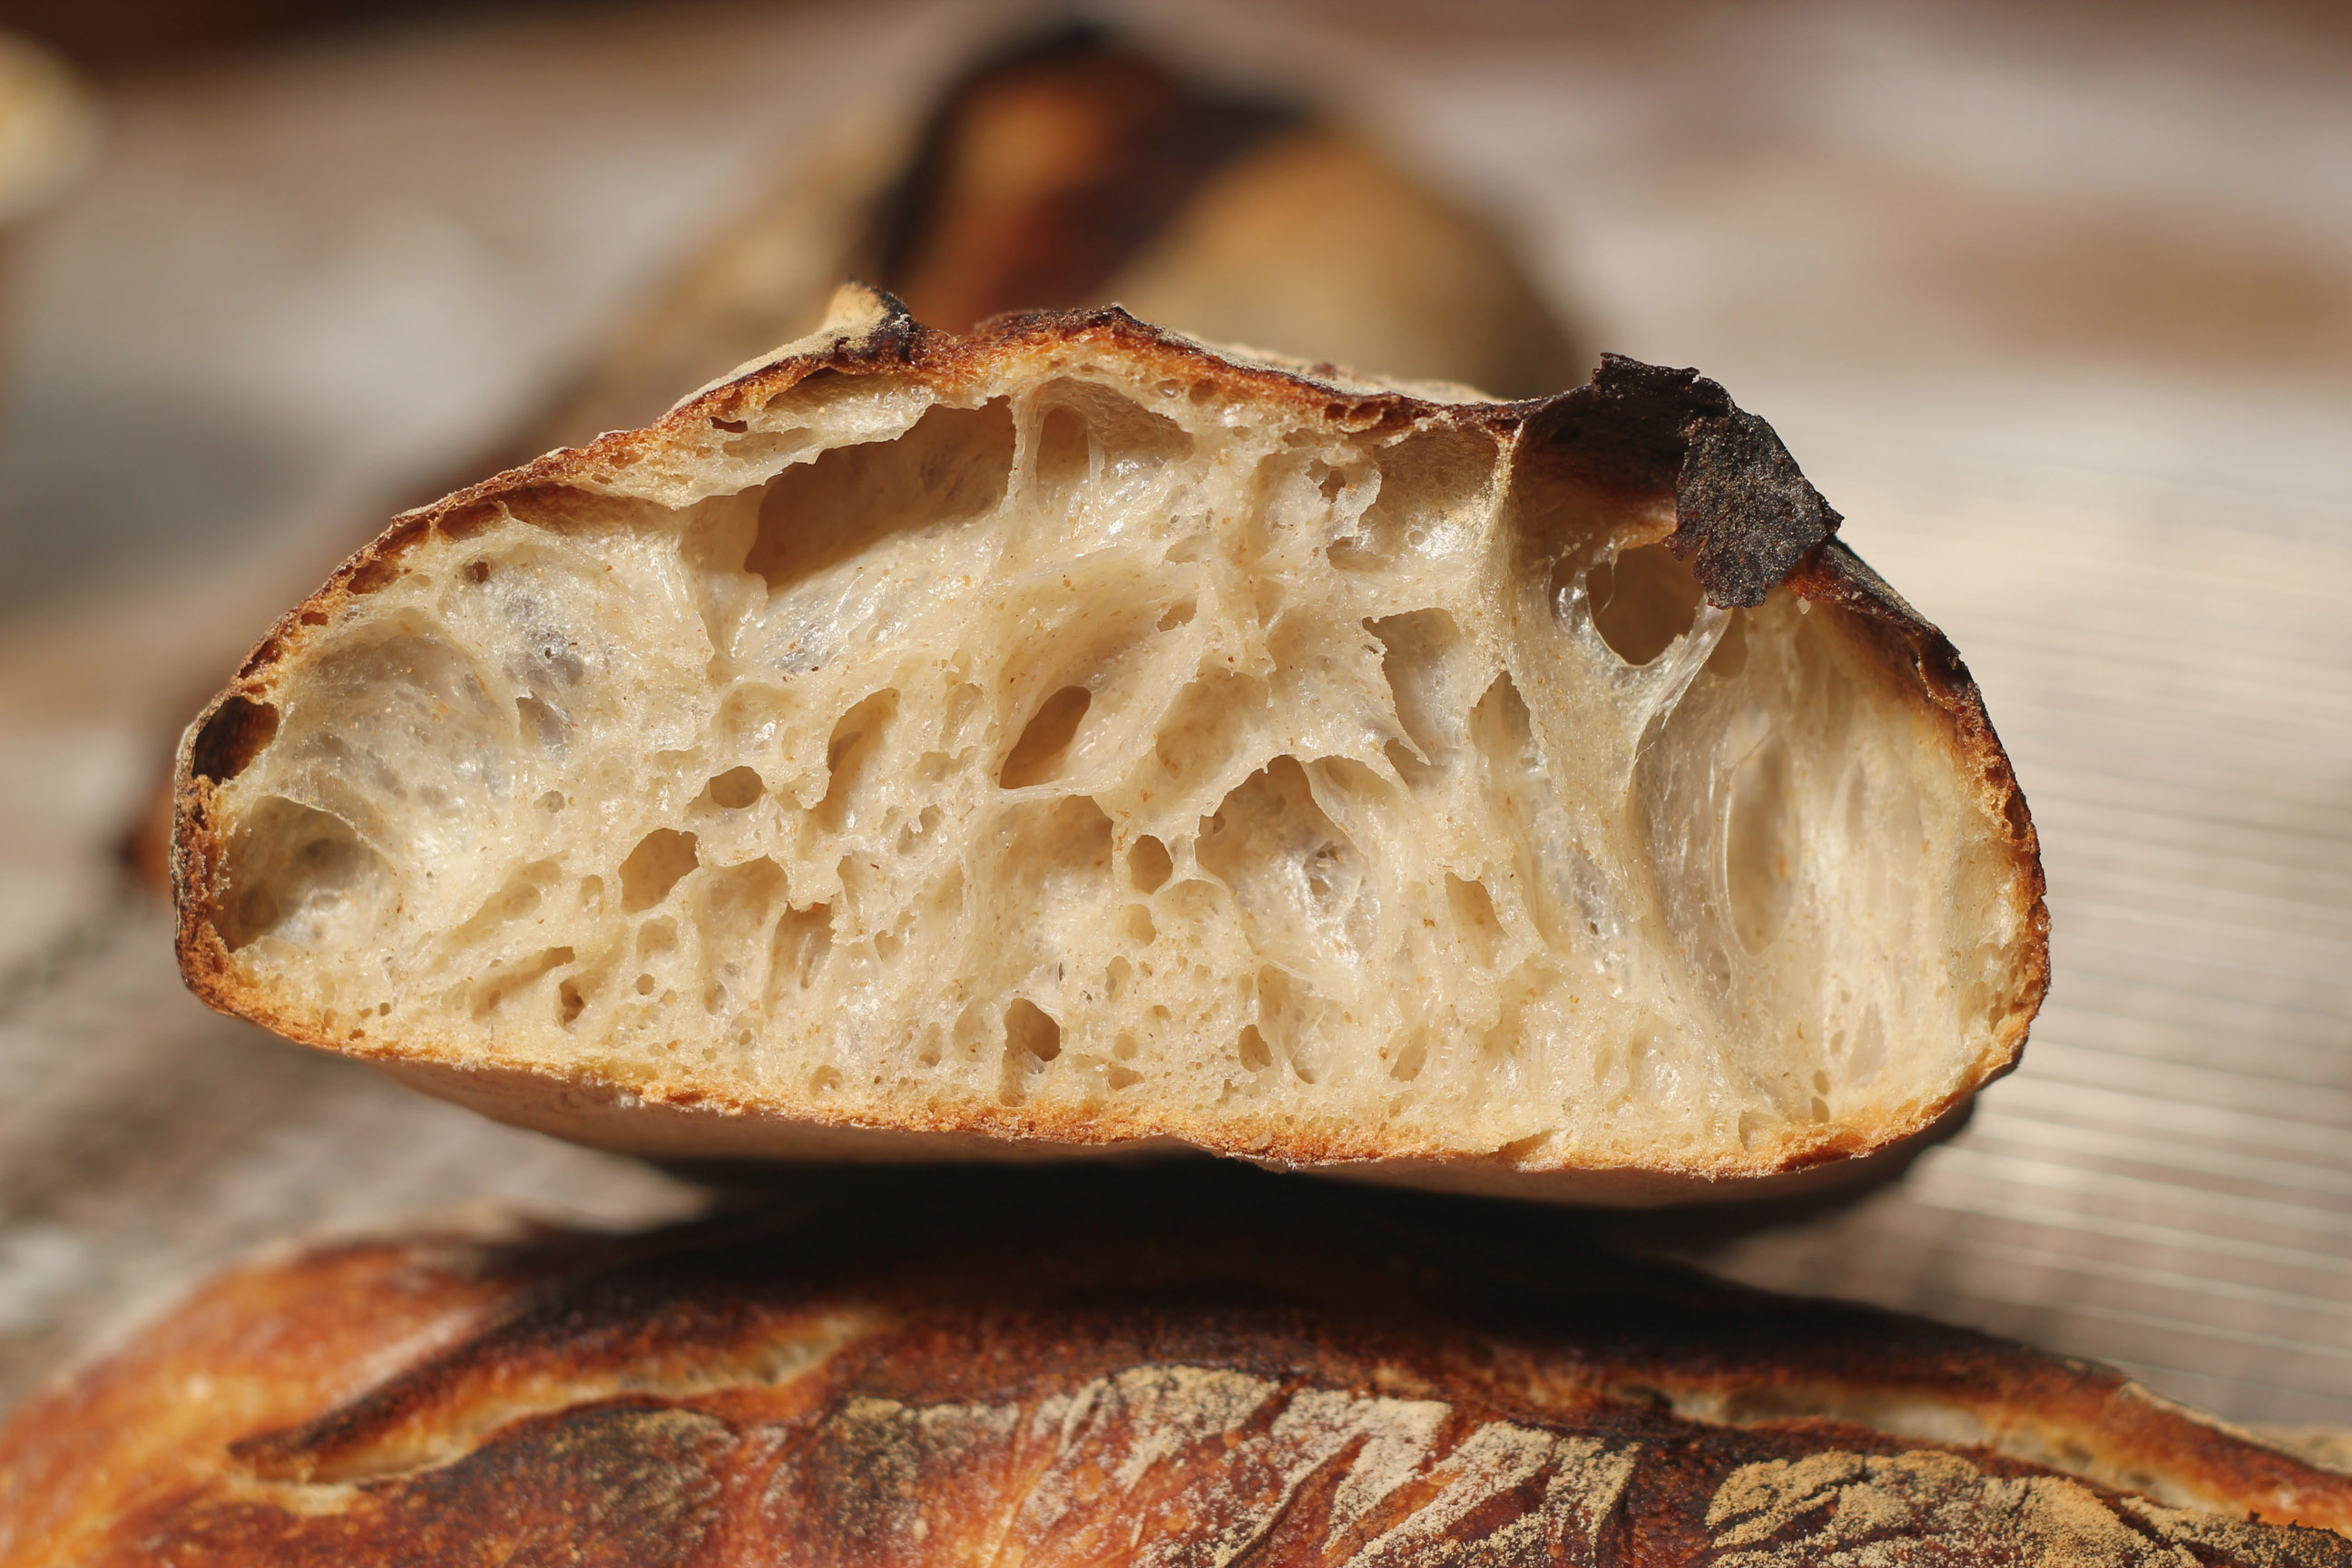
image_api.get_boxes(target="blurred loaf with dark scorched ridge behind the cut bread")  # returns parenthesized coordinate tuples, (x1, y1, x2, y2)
(524, 25, 1592, 454)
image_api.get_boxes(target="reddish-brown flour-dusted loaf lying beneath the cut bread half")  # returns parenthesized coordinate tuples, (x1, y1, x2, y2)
(0, 1166, 2352, 1568)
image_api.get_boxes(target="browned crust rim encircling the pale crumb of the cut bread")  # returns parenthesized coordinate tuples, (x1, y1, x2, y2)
(172, 287, 2049, 1201)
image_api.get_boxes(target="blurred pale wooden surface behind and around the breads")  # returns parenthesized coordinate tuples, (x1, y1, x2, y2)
(0, 3, 2352, 1427)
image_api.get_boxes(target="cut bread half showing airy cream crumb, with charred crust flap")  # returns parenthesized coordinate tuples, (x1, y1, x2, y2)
(174, 289, 2049, 1201)
